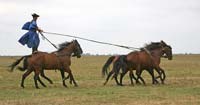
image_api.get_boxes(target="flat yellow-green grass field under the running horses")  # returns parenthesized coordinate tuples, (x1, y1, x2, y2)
(0, 55, 200, 105)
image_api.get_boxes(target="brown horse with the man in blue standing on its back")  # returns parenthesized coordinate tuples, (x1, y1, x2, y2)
(11, 40, 83, 88)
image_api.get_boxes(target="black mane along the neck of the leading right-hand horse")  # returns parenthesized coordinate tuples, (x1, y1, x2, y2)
(140, 42, 162, 51)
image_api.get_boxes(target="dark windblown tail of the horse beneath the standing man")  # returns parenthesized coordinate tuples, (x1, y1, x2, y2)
(9, 55, 31, 72)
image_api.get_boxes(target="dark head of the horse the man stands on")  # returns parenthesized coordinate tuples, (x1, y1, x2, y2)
(72, 40, 83, 58)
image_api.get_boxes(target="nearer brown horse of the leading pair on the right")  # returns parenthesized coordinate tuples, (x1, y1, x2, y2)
(120, 41, 172, 84)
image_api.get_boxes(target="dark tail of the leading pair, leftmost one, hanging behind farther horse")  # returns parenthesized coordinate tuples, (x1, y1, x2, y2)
(102, 56, 115, 77)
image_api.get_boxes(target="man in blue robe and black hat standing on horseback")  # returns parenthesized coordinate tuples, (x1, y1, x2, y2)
(19, 13, 43, 53)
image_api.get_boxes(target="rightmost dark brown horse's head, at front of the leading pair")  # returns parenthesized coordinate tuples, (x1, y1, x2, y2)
(161, 41, 172, 60)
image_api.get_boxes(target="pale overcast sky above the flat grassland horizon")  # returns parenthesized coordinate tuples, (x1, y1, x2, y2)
(0, 0, 200, 55)
